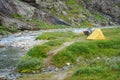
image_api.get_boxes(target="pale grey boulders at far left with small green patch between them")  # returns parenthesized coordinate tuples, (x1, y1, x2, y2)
(0, 0, 35, 30)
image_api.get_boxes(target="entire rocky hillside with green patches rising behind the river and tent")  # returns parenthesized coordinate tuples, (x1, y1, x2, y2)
(0, 0, 120, 32)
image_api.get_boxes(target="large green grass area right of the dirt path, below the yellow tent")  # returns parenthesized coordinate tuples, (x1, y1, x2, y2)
(53, 28, 120, 80)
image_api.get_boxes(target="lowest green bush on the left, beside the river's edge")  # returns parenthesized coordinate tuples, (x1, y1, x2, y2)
(17, 56, 43, 73)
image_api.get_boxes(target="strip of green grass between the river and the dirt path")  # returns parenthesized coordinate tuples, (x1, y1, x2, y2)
(17, 32, 81, 72)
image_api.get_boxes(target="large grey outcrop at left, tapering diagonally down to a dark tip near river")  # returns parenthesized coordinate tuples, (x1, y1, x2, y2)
(0, 0, 70, 30)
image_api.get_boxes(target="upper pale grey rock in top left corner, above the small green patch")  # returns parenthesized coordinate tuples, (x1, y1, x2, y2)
(0, 0, 35, 17)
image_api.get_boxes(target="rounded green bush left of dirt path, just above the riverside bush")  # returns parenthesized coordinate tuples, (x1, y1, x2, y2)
(27, 45, 49, 58)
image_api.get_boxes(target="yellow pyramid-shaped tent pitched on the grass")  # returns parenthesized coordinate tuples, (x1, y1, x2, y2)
(87, 29, 105, 40)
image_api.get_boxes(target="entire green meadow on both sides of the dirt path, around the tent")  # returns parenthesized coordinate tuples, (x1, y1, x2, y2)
(17, 28, 120, 80)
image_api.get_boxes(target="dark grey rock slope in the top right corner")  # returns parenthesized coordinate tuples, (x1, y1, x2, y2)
(83, 0, 120, 24)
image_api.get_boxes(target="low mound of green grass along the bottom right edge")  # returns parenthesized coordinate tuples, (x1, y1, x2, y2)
(64, 66, 120, 80)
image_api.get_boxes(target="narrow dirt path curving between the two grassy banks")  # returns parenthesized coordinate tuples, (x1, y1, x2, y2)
(43, 42, 74, 67)
